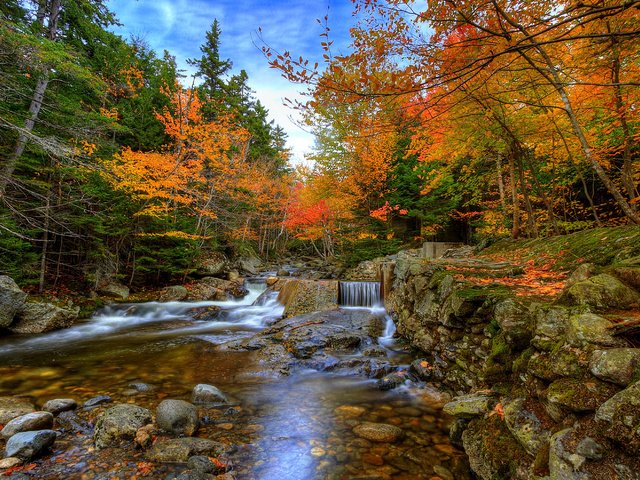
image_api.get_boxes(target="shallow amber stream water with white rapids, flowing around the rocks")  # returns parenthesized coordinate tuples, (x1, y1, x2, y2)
(0, 281, 468, 480)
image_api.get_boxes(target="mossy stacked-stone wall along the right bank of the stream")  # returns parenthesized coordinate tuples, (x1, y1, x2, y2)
(381, 232, 640, 480)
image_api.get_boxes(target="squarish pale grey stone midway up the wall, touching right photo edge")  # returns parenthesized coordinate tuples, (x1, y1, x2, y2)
(589, 348, 640, 387)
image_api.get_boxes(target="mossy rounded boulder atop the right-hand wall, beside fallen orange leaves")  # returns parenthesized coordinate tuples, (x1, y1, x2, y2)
(559, 273, 640, 309)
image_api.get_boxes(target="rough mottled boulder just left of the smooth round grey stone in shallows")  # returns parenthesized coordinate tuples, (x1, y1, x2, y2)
(93, 404, 151, 449)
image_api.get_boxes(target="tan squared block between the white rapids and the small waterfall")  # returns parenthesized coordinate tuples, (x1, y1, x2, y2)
(277, 279, 338, 317)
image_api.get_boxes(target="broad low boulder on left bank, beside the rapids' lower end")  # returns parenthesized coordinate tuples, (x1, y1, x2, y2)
(9, 303, 80, 333)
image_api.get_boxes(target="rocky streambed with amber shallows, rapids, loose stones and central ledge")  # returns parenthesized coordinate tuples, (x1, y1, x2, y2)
(0, 280, 470, 480)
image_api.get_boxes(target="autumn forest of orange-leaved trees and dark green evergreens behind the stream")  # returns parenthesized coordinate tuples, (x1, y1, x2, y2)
(0, 0, 640, 291)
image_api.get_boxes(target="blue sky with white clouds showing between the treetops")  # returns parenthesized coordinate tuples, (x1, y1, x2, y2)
(108, 0, 354, 162)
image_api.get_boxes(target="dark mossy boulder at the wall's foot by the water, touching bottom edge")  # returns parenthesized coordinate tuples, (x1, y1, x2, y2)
(462, 415, 532, 480)
